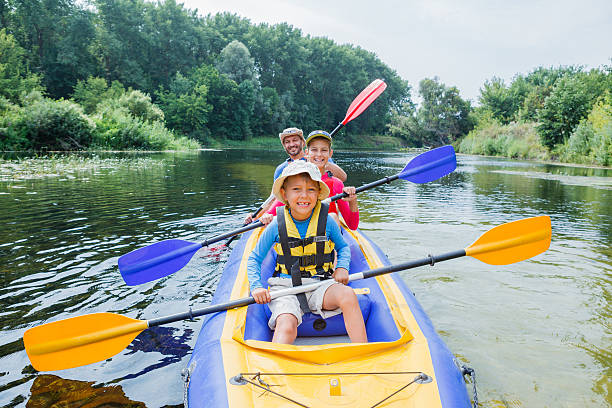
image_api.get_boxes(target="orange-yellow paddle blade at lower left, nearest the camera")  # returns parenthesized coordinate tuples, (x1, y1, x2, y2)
(23, 313, 148, 371)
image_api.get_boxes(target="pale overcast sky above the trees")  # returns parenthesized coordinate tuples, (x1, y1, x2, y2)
(177, 0, 612, 101)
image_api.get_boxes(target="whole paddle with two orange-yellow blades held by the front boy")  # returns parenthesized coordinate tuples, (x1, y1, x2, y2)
(23, 216, 551, 371)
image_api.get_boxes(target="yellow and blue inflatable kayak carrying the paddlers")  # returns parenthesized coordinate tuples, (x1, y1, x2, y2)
(183, 227, 470, 408)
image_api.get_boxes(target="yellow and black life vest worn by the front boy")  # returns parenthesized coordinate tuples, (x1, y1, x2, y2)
(274, 201, 334, 278)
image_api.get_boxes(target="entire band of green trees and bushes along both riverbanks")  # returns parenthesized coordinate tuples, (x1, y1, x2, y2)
(0, 0, 612, 166)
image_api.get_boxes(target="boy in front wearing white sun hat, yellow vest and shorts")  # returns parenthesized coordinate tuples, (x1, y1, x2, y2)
(247, 160, 367, 344)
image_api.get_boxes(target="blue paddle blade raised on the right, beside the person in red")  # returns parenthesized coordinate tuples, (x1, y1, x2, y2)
(398, 145, 457, 184)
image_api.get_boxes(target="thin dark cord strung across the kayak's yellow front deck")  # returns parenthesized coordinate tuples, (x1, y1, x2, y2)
(230, 371, 432, 408)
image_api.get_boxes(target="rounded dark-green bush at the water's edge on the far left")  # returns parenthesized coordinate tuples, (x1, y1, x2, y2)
(10, 94, 95, 150)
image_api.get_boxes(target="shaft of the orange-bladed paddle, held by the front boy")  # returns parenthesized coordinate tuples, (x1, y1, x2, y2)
(147, 245, 466, 327)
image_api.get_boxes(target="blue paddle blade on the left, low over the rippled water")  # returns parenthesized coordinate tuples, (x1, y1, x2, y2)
(118, 239, 202, 286)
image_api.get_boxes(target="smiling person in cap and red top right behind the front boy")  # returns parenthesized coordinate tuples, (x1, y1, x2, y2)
(306, 130, 359, 230)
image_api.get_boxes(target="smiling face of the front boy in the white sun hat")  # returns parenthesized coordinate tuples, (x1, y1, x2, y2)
(280, 173, 319, 221)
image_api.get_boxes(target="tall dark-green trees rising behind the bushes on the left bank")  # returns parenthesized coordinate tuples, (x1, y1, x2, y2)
(0, 0, 410, 149)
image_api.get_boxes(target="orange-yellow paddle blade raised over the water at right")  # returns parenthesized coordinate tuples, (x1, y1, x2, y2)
(465, 215, 551, 265)
